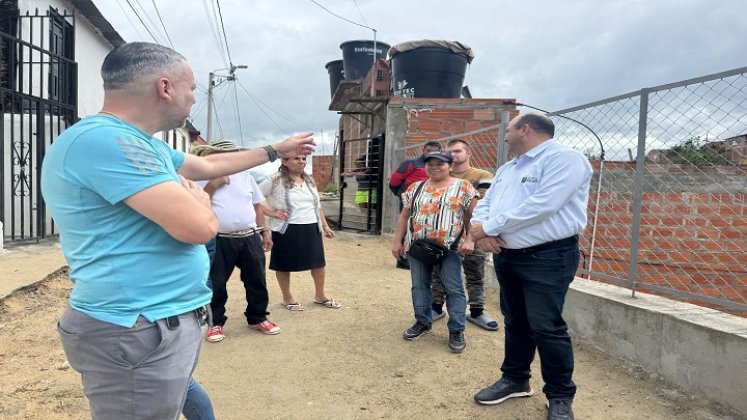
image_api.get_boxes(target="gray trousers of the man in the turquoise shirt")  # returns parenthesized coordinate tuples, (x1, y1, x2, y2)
(57, 307, 204, 420)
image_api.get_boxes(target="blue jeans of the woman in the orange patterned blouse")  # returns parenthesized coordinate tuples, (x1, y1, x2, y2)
(407, 251, 467, 332)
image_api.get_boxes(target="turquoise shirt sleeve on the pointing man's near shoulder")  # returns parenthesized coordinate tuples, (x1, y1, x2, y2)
(65, 130, 184, 204)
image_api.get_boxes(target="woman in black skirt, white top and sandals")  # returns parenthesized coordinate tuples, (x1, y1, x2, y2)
(259, 156, 340, 311)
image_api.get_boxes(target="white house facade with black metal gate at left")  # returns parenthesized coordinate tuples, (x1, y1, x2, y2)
(0, 0, 124, 245)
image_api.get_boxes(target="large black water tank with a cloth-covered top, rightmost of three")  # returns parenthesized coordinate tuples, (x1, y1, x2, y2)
(389, 40, 474, 98)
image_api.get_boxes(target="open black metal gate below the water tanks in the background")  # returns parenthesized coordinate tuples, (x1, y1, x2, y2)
(338, 134, 384, 234)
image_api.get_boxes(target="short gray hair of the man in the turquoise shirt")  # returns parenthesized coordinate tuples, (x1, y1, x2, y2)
(101, 42, 187, 90)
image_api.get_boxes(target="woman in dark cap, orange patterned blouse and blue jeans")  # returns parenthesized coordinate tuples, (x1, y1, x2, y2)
(392, 151, 479, 353)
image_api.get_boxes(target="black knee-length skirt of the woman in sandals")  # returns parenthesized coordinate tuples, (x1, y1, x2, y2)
(270, 223, 327, 271)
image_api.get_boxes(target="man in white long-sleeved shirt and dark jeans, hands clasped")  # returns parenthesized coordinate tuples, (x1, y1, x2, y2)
(470, 114, 593, 420)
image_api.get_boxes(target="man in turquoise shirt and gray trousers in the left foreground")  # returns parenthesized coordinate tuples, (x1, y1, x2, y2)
(42, 43, 314, 419)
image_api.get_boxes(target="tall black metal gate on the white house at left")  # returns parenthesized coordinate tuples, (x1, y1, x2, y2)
(0, 4, 78, 242)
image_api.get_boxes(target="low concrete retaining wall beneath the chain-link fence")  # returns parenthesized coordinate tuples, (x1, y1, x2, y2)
(485, 263, 747, 416)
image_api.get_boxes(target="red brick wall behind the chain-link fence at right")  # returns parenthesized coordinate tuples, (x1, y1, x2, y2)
(581, 163, 747, 315)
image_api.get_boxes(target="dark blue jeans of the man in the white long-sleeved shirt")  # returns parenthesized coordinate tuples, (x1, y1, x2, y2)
(493, 237, 579, 399)
